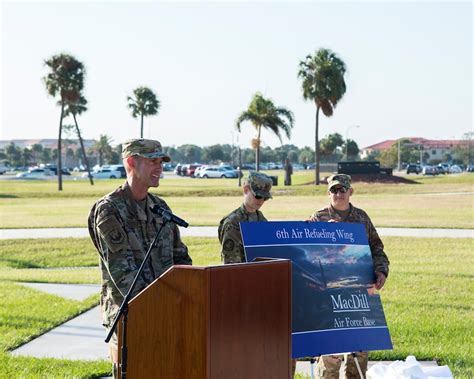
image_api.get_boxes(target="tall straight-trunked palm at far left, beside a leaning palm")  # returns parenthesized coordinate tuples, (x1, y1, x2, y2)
(43, 54, 85, 191)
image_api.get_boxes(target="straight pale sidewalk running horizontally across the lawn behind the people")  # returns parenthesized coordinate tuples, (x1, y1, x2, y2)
(0, 226, 474, 239)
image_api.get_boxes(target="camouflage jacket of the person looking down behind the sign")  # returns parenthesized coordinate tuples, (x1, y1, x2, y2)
(218, 204, 267, 263)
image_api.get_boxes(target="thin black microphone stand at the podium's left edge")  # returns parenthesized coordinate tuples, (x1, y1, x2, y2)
(105, 217, 169, 379)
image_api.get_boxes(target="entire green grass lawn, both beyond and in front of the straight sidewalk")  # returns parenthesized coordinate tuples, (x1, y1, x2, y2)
(0, 172, 474, 378)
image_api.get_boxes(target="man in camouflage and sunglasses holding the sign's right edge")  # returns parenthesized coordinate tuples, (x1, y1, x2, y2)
(310, 174, 389, 379)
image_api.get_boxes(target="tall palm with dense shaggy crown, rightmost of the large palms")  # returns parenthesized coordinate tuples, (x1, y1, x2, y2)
(298, 49, 346, 185)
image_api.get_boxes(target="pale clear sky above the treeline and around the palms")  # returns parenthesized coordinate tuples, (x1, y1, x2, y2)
(0, 1, 473, 147)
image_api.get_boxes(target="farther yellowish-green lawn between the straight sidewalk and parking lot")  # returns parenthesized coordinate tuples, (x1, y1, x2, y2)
(0, 172, 474, 229)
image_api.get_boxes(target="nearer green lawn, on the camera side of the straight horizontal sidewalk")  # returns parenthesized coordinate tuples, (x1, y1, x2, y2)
(0, 237, 474, 378)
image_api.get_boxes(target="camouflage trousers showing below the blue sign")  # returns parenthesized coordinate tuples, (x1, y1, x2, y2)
(316, 352, 368, 379)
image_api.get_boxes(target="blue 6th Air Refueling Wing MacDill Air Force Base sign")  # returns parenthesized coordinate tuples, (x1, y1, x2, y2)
(240, 222, 392, 358)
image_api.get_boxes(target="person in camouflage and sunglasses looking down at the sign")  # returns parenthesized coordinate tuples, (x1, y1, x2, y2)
(218, 171, 272, 264)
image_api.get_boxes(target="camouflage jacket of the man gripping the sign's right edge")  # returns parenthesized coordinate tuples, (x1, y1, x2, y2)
(310, 204, 390, 276)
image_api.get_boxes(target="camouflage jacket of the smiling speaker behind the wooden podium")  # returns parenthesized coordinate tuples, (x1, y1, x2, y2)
(88, 183, 192, 327)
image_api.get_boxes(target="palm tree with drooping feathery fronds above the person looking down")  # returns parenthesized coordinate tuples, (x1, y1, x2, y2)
(235, 92, 294, 171)
